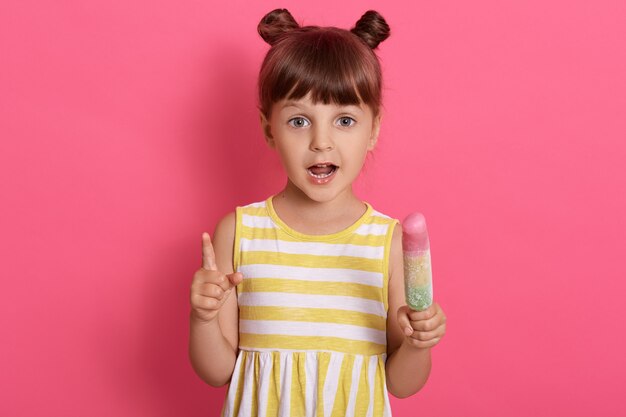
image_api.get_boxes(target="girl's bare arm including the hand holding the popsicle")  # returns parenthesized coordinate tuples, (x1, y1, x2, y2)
(386, 225, 445, 398)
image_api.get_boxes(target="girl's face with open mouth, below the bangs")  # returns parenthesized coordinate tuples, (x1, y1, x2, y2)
(261, 95, 380, 202)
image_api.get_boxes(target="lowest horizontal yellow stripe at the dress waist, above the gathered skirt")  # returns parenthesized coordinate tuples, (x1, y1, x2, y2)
(239, 333, 386, 355)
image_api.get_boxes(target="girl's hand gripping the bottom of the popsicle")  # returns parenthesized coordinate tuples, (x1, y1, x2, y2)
(398, 303, 446, 349)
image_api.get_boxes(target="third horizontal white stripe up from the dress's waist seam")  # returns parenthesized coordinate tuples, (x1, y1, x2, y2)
(238, 264, 383, 288)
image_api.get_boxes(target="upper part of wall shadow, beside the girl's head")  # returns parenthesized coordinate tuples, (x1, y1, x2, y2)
(185, 41, 283, 214)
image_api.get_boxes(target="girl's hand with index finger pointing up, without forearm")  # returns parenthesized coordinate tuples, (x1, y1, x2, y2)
(190, 233, 243, 322)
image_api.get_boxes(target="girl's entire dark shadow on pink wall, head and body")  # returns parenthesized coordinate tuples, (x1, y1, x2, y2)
(131, 41, 281, 417)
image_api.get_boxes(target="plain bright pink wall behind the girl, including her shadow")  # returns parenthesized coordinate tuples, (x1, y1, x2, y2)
(0, 0, 626, 417)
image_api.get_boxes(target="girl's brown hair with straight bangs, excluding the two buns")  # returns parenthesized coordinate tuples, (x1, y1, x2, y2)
(259, 27, 381, 117)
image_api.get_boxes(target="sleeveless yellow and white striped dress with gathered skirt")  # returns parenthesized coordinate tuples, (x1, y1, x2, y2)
(222, 197, 398, 417)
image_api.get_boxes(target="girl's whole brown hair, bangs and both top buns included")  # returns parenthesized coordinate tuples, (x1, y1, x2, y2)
(258, 9, 389, 118)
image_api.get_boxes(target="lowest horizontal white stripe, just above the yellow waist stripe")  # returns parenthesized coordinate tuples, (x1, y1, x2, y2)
(239, 320, 387, 345)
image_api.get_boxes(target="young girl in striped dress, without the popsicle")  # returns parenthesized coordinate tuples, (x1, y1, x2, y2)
(189, 9, 445, 417)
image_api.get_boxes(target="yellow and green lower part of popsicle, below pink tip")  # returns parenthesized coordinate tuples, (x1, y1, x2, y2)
(404, 250, 433, 311)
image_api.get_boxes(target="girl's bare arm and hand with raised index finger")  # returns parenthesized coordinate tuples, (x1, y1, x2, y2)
(189, 213, 243, 387)
